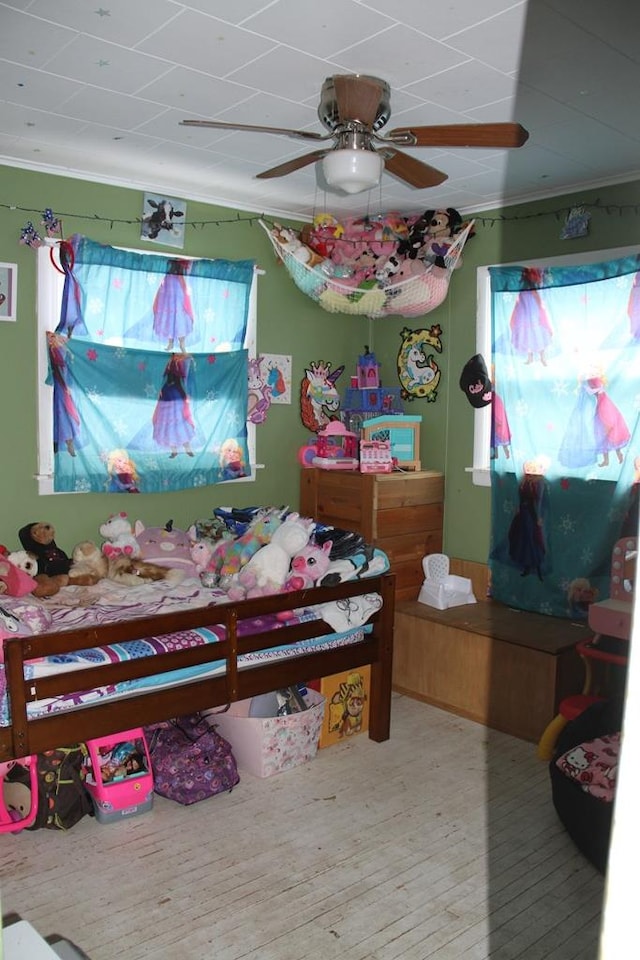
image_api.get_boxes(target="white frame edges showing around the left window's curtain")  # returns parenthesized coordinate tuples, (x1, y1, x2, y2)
(36, 238, 263, 496)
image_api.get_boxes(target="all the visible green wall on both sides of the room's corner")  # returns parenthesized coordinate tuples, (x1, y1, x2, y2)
(0, 166, 640, 561)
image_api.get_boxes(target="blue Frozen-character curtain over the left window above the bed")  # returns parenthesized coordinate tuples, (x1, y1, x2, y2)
(47, 236, 254, 493)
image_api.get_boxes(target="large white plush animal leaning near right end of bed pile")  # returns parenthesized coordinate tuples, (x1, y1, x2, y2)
(227, 513, 315, 600)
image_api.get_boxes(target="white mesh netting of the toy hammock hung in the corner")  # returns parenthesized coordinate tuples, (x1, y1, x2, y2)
(260, 220, 473, 318)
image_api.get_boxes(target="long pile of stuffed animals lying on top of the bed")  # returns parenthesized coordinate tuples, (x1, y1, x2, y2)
(0, 507, 382, 601)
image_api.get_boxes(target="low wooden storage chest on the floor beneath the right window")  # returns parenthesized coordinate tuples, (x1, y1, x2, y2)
(393, 600, 590, 742)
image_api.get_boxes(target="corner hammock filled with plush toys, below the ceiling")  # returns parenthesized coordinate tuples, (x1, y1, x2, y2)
(262, 207, 471, 316)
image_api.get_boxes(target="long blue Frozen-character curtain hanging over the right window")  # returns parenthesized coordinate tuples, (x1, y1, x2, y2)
(489, 256, 640, 619)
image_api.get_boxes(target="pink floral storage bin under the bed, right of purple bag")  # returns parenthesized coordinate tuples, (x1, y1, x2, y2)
(209, 690, 325, 777)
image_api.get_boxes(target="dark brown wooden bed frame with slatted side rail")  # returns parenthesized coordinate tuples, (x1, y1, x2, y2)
(0, 573, 395, 761)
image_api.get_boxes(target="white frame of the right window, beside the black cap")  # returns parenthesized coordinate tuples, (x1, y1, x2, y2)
(470, 247, 640, 487)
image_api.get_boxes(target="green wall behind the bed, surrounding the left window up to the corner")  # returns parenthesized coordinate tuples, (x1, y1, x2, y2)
(0, 166, 368, 553)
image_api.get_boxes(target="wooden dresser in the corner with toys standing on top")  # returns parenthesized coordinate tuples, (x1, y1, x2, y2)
(300, 467, 444, 600)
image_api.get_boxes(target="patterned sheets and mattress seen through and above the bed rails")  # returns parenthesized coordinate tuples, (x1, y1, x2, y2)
(0, 579, 381, 726)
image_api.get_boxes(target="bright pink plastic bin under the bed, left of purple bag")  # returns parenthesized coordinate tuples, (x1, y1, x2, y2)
(85, 727, 153, 823)
